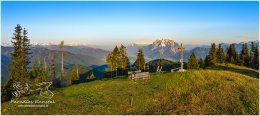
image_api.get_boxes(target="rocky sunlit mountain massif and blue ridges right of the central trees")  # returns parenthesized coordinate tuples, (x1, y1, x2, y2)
(127, 39, 259, 62)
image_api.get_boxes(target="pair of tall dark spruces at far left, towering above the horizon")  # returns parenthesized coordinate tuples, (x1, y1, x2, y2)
(1, 24, 31, 101)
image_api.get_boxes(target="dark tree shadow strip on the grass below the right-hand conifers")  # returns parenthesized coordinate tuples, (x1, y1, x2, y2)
(207, 65, 259, 79)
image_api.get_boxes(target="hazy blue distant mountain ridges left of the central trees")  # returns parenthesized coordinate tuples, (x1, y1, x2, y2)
(1, 46, 107, 81)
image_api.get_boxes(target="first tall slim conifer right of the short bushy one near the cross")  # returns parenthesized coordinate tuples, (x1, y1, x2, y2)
(209, 43, 217, 65)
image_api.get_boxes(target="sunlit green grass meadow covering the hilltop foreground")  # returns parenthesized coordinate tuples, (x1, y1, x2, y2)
(2, 65, 259, 114)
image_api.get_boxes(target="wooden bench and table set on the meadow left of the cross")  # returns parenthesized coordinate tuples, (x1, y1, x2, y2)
(128, 70, 150, 80)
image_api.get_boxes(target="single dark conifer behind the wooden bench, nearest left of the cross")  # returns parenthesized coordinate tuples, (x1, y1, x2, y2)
(134, 49, 145, 70)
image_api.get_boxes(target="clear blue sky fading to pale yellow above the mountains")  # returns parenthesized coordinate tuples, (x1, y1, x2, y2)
(1, 1, 259, 45)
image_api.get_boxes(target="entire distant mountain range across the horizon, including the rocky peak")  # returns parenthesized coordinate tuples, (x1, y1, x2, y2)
(1, 39, 259, 83)
